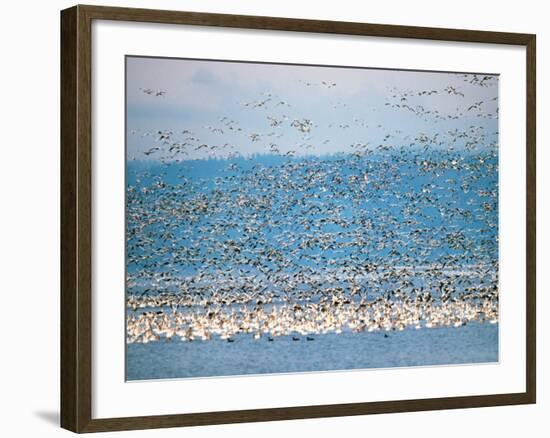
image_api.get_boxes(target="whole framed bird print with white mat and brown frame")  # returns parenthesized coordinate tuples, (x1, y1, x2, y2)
(61, 6, 536, 432)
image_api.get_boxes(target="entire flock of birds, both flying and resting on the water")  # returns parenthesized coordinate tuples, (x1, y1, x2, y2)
(126, 70, 499, 343)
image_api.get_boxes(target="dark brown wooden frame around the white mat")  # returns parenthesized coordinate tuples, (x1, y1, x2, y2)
(61, 5, 536, 433)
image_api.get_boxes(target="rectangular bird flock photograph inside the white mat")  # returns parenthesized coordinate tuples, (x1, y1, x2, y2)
(127, 55, 499, 381)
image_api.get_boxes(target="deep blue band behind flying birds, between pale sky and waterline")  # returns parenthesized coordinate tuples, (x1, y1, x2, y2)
(127, 151, 498, 295)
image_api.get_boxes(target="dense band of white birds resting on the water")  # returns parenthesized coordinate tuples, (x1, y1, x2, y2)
(127, 295, 498, 343)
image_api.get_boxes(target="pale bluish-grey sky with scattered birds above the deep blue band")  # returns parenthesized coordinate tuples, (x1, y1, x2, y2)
(126, 57, 498, 161)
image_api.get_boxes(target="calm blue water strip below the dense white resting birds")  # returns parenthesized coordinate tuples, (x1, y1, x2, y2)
(126, 323, 499, 380)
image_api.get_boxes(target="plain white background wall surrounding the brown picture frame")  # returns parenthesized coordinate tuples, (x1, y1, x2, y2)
(0, 0, 550, 438)
